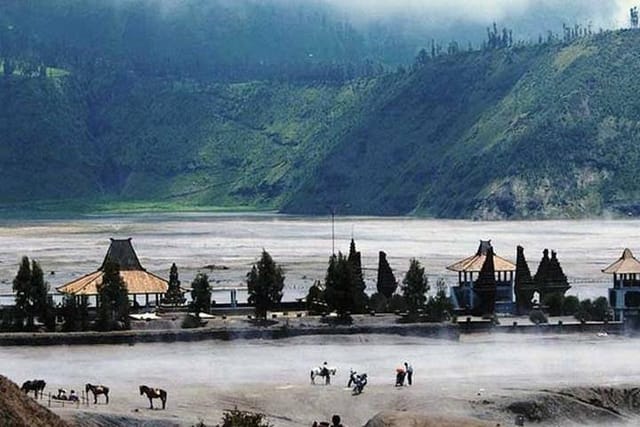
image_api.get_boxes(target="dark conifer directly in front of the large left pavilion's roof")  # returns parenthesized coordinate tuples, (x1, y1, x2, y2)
(97, 262, 129, 331)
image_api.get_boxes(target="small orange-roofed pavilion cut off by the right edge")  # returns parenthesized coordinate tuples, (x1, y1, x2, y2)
(602, 248, 640, 321)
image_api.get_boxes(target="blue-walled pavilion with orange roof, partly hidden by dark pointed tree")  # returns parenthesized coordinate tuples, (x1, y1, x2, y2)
(447, 240, 516, 314)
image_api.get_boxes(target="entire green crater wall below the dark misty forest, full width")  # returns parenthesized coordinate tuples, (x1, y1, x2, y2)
(0, 21, 640, 218)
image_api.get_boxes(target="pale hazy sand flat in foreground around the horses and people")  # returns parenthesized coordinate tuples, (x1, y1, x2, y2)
(0, 334, 640, 427)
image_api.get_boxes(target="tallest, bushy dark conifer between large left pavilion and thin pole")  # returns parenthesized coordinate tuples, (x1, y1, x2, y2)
(247, 249, 284, 319)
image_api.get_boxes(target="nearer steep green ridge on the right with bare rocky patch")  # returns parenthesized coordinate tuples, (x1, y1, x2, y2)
(286, 31, 640, 218)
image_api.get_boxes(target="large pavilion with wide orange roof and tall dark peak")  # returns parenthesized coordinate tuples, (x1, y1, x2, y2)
(57, 238, 169, 305)
